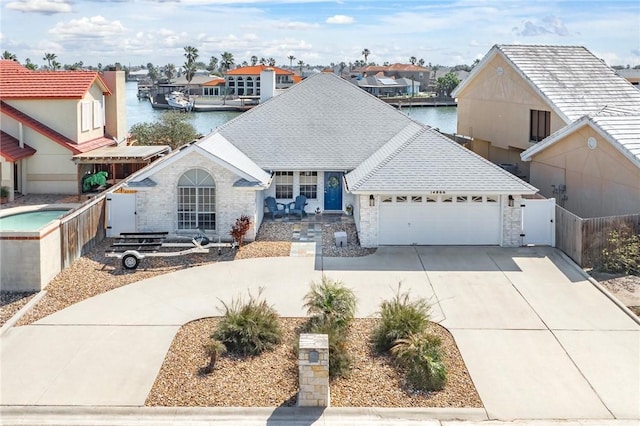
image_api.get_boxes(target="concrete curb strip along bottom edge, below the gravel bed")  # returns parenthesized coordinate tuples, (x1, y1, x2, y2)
(0, 406, 488, 425)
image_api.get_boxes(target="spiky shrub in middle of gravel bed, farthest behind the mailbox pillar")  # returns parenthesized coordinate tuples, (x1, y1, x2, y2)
(304, 275, 357, 328)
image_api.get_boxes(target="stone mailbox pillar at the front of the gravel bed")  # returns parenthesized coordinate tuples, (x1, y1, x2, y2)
(298, 334, 329, 407)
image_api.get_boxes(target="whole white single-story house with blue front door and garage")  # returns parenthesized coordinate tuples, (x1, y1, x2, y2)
(118, 73, 536, 247)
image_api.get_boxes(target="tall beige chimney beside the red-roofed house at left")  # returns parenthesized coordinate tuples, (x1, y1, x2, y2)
(102, 71, 127, 142)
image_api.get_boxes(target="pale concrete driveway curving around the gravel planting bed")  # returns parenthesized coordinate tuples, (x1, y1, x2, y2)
(0, 247, 640, 420)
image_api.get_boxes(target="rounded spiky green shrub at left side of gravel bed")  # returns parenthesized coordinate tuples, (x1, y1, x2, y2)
(211, 289, 282, 356)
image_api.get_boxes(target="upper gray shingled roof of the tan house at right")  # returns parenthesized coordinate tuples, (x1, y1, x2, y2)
(496, 45, 640, 123)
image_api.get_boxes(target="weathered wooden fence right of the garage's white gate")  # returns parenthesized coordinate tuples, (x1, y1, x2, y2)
(556, 205, 640, 268)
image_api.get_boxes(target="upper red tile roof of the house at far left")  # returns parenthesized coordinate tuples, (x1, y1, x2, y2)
(0, 59, 111, 99)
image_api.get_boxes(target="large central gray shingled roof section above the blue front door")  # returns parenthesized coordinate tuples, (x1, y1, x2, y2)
(216, 73, 414, 171)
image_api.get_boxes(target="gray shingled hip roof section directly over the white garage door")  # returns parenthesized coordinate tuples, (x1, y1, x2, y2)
(346, 126, 537, 194)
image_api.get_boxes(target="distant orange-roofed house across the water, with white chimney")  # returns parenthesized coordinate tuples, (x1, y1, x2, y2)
(224, 65, 294, 97)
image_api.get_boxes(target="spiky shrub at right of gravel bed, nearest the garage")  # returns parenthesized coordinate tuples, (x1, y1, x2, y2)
(373, 284, 431, 352)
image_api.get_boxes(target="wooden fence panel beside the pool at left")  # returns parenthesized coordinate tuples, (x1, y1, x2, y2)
(60, 195, 106, 269)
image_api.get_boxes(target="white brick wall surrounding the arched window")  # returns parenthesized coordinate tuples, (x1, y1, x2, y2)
(136, 152, 261, 241)
